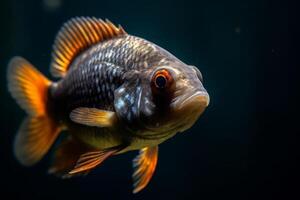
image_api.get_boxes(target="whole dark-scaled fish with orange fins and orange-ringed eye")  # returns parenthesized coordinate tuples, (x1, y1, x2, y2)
(7, 17, 210, 193)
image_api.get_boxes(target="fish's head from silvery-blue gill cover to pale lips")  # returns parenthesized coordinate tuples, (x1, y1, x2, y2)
(114, 62, 209, 137)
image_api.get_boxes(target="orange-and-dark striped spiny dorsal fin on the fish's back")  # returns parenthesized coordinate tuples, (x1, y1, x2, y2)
(50, 17, 126, 77)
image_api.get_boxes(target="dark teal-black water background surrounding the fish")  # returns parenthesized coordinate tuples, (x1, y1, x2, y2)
(0, 0, 300, 200)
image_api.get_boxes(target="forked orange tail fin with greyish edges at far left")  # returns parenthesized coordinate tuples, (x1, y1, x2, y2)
(7, 57, 60, 166)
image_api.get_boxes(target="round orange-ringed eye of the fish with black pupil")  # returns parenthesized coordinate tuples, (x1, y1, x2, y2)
(152, 69, 173, 89)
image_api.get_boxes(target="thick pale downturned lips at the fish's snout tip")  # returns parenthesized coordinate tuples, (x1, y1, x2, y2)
(178, 91, 210, 109)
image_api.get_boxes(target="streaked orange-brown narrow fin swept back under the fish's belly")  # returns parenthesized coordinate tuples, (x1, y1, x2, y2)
(69, 146, 123, 175)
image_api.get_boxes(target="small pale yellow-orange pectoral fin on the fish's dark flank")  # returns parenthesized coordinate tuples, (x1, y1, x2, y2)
(70, 108, 117, 127)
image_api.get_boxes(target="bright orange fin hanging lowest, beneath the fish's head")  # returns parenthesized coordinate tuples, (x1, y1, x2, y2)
(132, 146, 158, 193)
